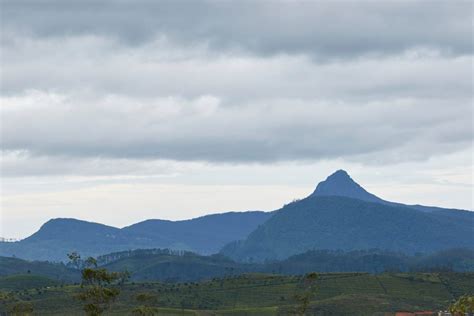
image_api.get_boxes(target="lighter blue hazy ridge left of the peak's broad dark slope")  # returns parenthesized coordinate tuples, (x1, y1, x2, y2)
(0, 211, 271, 261)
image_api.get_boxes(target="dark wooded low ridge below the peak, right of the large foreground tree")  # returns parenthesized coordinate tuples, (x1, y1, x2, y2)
(96, 249, 474, 282)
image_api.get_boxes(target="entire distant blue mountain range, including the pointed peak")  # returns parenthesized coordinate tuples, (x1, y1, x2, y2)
(0, 170, 474, 262)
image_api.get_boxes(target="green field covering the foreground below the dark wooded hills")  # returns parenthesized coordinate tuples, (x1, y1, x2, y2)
(0, 273, 474, 315)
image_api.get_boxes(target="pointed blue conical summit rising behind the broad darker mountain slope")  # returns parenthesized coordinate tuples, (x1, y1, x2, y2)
(312, 170, 385, 203)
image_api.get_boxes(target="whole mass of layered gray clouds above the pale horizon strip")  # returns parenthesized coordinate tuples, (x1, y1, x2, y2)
(0, 1, 473, 176)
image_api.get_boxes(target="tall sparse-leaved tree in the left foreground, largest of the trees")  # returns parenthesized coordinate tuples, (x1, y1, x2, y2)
(68, 253, 130, 316)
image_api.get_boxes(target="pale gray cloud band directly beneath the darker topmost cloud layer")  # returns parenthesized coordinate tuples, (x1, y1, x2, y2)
(2, 36, 472, 97)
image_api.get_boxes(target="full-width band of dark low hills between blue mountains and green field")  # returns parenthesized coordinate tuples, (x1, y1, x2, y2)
(0, 249, 474, 284)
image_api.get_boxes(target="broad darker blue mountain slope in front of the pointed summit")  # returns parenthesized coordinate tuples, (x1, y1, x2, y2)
(221, 195, 474, 262)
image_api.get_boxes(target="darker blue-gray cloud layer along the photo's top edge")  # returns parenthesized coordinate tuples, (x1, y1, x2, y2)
(2, 0, 472, 60)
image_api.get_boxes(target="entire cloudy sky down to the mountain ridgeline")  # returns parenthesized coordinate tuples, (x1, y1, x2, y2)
(0, 0, 474, 238)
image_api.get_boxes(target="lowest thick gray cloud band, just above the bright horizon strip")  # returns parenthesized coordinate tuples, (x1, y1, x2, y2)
(2, 93, 472, 168)
